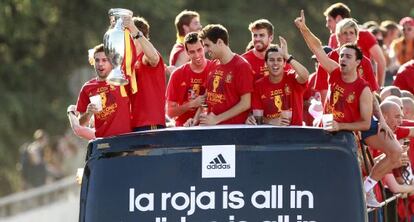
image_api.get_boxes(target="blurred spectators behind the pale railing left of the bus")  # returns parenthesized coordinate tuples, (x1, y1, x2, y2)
(18, 129, 86, 190)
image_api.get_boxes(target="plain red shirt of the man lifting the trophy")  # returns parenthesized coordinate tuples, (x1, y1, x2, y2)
(131, 53, 166, 128)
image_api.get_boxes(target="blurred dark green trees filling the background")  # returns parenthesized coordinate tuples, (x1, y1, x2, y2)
(0, 0, 414, 196)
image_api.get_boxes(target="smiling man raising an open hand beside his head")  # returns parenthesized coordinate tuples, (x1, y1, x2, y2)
(247, 37, 309, 126)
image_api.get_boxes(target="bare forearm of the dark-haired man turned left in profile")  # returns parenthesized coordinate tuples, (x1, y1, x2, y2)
(200, 93, 251, 125)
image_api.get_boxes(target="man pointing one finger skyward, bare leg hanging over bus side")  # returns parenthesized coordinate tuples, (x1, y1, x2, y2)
(295, 10, 402, 207)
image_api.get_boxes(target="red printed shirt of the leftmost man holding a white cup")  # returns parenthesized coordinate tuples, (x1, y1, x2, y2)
(76, 78, 131, 137)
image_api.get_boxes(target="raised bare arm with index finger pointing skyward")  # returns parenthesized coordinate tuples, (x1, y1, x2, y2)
(295, 10, 339, 73)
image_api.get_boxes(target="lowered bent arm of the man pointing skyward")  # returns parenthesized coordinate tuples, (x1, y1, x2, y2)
(338, 87, 372, 131)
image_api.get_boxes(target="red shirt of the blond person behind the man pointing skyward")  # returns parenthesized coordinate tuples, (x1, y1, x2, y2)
(315, 50, 379, 91)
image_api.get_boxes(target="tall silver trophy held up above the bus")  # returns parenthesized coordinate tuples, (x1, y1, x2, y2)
(103, 8, 132, 86)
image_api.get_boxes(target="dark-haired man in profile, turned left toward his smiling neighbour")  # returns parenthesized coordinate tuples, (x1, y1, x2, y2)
(200, 24, 253, 125)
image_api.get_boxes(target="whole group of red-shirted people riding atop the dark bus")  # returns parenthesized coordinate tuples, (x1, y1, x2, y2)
(68, 3, 414, 221)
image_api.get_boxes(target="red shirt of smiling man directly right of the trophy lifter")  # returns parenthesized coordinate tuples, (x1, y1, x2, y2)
(167, 60, 214, 126)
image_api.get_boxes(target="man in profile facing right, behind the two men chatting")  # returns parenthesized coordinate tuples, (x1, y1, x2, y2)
(170, 10, 202, 67)
